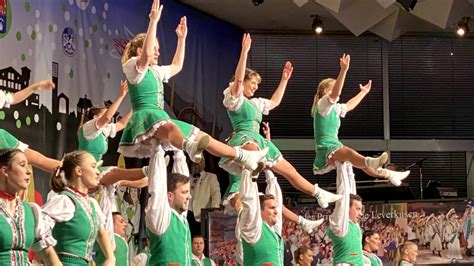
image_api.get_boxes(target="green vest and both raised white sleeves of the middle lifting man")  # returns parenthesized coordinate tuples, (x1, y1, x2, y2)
(237, 170, 284, 266)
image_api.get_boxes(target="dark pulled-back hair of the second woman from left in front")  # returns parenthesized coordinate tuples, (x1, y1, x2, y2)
(50, 151, 88, 193)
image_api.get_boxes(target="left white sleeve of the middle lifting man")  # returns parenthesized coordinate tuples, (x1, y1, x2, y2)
(237, 170, 263, 244)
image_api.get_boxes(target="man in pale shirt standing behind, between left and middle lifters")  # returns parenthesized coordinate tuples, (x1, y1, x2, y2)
(189, 158, 221, 222)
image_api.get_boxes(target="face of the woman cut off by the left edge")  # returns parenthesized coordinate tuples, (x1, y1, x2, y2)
(0, 151, 31, 193)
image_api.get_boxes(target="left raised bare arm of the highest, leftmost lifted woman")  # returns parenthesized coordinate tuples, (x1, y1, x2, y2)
(137, 0, 163, 72)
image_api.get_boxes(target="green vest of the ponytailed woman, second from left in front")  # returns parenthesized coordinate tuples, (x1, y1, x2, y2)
(53, 191, 99, 263)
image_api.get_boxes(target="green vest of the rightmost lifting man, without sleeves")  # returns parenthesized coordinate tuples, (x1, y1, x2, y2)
(327, 221, 364, 266)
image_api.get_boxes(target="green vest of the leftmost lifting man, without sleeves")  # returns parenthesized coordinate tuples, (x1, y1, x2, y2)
(148, 211, 192, 266)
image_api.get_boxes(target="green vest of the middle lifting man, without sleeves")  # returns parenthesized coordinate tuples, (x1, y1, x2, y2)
(242, 222, 284, 266)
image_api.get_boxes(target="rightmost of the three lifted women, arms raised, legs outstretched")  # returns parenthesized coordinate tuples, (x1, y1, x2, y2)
(311, 54, 410, 186)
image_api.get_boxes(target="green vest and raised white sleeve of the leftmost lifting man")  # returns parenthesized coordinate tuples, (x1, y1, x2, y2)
(145, 146, 192, 266)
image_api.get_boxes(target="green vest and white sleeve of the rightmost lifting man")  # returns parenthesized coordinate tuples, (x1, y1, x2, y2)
(327, 161, 364, 266)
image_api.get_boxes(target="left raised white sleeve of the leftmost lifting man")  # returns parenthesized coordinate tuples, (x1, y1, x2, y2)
(145, 146, 171, 235)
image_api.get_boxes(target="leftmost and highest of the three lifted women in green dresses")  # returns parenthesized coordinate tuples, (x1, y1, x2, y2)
(119, 0, 267, 175)
